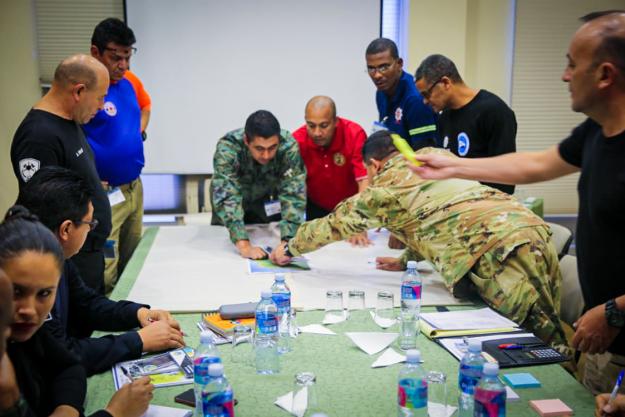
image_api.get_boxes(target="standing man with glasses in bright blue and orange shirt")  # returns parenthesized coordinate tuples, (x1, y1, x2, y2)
(83, 18, 151, 293)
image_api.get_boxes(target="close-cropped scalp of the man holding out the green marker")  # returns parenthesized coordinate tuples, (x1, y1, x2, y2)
(579, 10, 625, 74)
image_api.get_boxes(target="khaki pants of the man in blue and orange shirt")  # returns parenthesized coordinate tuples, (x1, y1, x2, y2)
(104, 178, 143, 294)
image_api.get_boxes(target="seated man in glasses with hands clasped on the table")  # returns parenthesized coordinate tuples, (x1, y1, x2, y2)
(17, 166, 184, 376)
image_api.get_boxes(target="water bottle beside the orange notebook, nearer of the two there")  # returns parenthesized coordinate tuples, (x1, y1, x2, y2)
(254, 291, 280, 374)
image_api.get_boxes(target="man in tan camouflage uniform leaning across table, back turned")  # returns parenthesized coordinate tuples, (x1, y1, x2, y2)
(271, 131, 569, 354)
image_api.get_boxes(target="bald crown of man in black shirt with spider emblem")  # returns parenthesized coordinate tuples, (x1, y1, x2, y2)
(54, 54, 108, 90)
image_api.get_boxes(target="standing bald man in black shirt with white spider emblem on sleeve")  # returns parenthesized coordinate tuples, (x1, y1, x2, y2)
(11, 55, 111, 294)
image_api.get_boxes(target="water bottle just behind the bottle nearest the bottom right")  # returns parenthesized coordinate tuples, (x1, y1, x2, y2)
(458, 339, 486, 417)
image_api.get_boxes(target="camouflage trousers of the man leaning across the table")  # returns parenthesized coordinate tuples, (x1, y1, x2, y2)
(469, 226, 572, 355)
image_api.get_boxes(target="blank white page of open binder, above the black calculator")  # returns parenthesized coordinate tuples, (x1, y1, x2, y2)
(421, 307, 518, 330)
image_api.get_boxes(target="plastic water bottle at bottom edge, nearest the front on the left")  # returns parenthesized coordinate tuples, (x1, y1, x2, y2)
(202, 363, 234, 417)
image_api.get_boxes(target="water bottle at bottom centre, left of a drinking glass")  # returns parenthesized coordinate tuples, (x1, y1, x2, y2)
(397, 349, 428, 417)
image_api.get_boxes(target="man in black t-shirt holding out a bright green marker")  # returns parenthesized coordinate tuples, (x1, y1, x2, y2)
(404, 11, 625, 393)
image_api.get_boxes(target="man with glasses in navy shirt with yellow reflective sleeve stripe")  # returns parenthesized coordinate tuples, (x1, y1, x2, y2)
(365, 38, 436, 150)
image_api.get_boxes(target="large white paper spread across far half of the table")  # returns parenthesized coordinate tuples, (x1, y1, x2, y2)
(128, 223, 461, 312)
